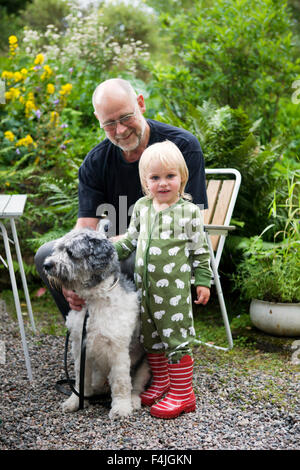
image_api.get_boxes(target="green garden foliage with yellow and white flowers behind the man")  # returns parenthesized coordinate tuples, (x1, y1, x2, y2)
(0, 0, 300, 302)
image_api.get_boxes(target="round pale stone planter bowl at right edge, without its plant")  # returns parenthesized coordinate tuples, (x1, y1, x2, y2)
(250, 299, 300, 337)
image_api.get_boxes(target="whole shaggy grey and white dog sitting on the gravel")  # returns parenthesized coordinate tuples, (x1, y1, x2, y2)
(44, 229, 150, 419)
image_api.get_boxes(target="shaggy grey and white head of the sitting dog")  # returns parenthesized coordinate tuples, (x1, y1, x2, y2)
(44, 229, 120, 291)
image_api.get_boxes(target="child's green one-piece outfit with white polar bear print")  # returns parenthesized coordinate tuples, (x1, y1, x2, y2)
(114, 197, 211, 362)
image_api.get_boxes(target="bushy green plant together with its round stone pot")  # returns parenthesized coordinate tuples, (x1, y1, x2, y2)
(234, 171, 300, 336)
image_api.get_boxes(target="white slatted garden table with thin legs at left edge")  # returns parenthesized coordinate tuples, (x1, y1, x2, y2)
(0, 194, 36, 382)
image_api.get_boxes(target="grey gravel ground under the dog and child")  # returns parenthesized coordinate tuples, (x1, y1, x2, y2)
(0, 302, 300, 451)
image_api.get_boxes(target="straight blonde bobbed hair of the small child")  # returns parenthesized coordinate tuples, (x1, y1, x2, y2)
(139, 140, 192, 199)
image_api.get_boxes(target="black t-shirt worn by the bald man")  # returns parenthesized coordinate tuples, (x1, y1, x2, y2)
(78, 119, 207, 235)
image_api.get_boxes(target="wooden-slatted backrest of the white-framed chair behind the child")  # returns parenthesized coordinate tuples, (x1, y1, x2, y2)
(204, 168, 242, 266)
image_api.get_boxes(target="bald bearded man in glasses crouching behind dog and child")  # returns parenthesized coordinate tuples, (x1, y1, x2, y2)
(35, 78, 207, 317)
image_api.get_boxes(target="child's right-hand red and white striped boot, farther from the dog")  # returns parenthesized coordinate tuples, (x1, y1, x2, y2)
(150, 355, 196, 419)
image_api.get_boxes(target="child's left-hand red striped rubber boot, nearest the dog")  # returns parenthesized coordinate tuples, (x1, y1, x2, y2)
(140, 353, 170, 406)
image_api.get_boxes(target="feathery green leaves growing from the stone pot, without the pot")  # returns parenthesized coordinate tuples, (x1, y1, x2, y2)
(233, 171, 300, 302)
